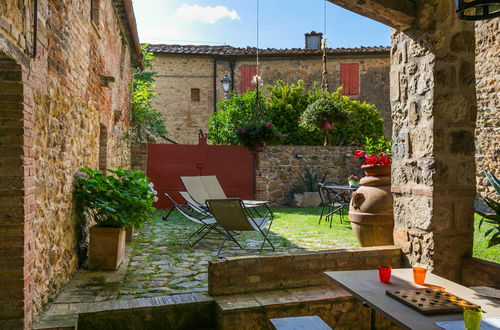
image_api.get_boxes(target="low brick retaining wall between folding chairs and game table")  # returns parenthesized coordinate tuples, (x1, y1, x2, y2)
(208, 246, 405, 296)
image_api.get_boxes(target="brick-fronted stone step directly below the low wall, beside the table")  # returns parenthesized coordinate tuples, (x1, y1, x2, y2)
(214, 285, 397, 330)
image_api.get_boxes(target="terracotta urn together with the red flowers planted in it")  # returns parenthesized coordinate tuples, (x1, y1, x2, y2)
(349, 137, 394, 246)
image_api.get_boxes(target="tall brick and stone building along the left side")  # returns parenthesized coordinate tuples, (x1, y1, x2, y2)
(0, 0, 142, 329)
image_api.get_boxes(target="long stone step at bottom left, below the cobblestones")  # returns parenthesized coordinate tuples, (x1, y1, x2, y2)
(33, 293, 215, 330)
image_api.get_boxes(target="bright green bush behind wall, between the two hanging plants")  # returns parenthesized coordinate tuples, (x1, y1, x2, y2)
(266, 80, 322, 145)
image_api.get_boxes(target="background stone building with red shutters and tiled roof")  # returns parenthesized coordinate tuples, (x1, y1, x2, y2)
(149, 33, 392, 144)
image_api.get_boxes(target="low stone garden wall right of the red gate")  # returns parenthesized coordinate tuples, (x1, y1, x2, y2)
(255, 146, 361, 205)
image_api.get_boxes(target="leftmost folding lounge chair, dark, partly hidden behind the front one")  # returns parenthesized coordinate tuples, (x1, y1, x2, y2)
(165, 193, 226, 246)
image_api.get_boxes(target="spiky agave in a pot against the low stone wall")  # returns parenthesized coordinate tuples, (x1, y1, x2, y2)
(291, 169, 327, 207)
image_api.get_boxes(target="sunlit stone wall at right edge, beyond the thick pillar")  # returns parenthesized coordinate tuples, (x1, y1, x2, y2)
(476, 17, 500, 198)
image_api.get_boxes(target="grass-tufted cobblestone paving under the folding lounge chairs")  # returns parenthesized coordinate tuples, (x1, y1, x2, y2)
(119, 214, 304, 299)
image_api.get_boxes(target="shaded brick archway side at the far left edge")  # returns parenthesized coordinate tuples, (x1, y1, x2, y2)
(0, 52, 31, 328)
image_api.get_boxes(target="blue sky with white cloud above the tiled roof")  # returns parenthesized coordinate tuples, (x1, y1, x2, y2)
(133, 0, 390, 48)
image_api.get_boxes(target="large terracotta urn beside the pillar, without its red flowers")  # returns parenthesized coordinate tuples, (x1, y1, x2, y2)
(349, 165, 394, 246)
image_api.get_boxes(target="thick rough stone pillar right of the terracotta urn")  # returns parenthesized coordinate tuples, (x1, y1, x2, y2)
(391, 0, 476, 280)
